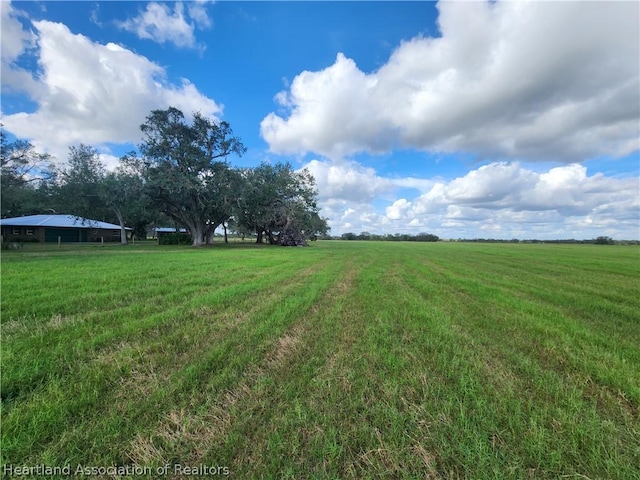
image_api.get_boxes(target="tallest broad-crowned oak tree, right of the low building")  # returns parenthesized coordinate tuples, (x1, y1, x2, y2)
(138, 107, 246, 247)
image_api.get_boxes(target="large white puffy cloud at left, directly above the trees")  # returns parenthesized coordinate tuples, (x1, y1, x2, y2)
(2, 2, 222, 158)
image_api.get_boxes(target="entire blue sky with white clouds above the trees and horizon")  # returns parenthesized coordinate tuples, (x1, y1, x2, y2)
(0, 0, 640, 240)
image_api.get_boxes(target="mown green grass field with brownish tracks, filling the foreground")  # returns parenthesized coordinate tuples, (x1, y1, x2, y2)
(1, 241, 640, 479)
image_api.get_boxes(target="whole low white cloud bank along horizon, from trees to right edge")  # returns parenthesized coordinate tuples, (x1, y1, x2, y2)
(310, 161, 640, 239)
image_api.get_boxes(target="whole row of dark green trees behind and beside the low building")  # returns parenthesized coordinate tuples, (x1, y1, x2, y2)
(0, 107, 329, 246)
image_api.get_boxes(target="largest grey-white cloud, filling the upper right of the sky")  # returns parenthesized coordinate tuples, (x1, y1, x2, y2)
(261, 1, 640, 163)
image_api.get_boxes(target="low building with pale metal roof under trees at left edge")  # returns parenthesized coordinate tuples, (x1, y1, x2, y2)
(0, 215, 131, 242)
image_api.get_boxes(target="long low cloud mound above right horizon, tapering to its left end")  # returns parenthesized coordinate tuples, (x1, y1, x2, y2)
(387, 162, 640, 239)
